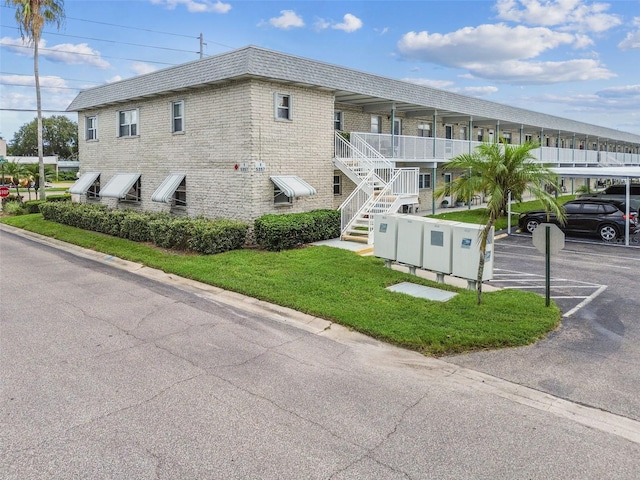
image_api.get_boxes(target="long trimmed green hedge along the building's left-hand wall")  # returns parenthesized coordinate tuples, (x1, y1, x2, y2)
(40, 202, 249, 255)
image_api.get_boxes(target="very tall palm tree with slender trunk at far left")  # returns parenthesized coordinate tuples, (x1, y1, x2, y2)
(6, 0, 64, 200)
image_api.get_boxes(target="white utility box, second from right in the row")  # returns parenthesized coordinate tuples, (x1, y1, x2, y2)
(422, 220, 460, 275)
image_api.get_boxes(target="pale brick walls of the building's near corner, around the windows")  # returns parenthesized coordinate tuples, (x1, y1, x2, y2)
(79, 80, 334, 221)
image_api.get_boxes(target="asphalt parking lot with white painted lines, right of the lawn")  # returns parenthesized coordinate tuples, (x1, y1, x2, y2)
(447, 235, 640, 420)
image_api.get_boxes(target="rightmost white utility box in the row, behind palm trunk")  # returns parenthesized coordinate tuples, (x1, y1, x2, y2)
(451, 223, 494, 281)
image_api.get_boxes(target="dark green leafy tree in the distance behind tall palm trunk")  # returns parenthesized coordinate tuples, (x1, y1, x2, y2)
(7, 115, 78, 159)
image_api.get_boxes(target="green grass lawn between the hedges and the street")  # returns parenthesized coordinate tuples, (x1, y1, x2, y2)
(1, 214, 560, 355)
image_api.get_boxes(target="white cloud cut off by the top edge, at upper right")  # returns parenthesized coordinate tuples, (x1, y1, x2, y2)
(495, 0, 622, 33)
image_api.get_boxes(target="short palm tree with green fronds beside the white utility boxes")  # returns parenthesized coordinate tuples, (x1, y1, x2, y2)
(434, 142, 565, 304)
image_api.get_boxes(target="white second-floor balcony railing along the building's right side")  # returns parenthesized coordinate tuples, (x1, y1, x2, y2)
(351, 132, 640, 166)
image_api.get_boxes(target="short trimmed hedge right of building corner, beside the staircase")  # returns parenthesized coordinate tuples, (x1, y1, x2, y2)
(254, 210, 340, 251)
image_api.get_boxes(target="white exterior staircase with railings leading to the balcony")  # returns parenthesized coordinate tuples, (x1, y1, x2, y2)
(334, 132, 419, 245)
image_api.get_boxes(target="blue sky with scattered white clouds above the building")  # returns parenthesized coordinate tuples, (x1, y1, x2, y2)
(0, 0, 640, 141)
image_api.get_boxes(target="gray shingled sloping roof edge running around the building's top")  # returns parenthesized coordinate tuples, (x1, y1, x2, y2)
(67, 46, 640, 144)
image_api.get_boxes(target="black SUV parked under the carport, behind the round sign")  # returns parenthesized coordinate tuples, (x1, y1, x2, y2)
(518, 198, 639, 241)
